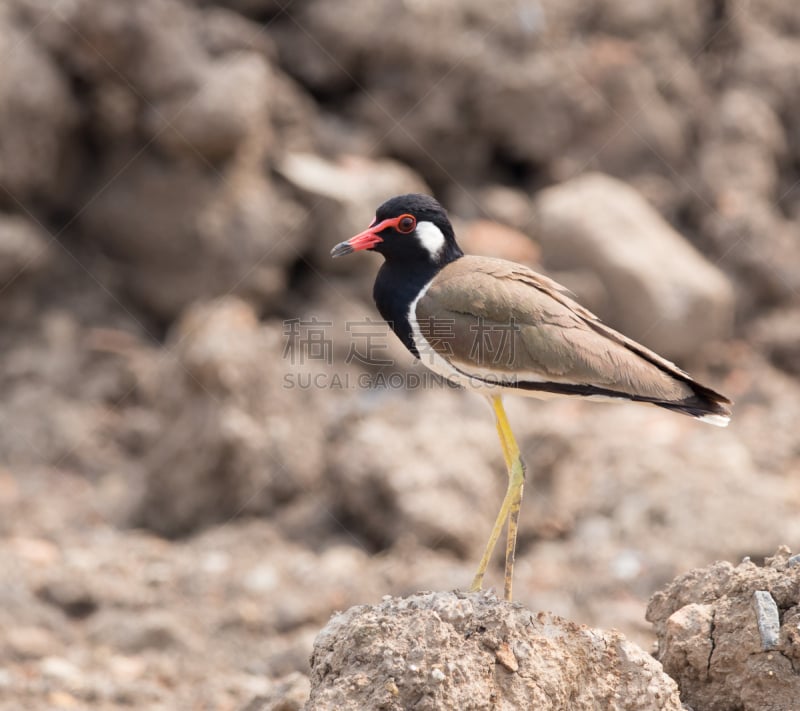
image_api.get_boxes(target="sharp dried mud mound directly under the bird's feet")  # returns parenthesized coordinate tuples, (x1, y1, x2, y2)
(306, 593, 681, 711)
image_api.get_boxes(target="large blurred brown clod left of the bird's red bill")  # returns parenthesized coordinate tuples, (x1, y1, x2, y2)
(80, 159, 306, 320)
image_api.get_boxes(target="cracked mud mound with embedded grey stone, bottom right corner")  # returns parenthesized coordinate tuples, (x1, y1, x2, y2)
(647, 548, 800, 711)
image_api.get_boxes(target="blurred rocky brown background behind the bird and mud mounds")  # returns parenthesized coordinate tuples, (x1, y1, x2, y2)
(0, 0, 800, 709)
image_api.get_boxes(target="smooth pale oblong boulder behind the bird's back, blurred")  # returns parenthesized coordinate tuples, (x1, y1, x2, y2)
(536, 173, 733, 359)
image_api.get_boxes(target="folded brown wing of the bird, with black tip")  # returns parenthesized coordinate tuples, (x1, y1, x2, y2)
(416, 257, 729, 415)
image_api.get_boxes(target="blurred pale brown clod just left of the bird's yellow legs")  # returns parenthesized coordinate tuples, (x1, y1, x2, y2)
(325, 392, 505, 560)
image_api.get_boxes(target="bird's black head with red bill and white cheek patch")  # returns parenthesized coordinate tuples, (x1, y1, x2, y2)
(331, 193, 463, 267)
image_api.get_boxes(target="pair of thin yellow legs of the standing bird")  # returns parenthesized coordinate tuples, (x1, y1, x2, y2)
(470, 395, 525, 601)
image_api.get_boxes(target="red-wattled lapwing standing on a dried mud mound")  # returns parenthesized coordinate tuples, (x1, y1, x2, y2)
(331, 194, 731, 600)
